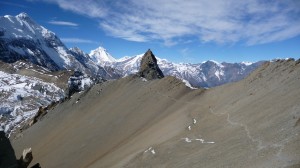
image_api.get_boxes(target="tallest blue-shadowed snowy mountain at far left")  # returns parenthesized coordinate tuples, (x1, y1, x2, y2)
(0, 13, 82, 70)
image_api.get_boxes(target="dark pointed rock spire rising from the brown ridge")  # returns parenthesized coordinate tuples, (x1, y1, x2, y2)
(138, 49, 164, 80)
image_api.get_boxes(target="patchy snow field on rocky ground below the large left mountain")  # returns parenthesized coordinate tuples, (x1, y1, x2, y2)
(0, 71, 64, 133)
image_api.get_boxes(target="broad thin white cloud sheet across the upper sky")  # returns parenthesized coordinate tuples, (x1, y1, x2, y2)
(38, 0, 300, 45)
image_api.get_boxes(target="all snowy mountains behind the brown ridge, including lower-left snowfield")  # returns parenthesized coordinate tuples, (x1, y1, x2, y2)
(0, 13, 263, 134)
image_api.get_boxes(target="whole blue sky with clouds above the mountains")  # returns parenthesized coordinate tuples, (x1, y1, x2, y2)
(0, 0, 300, 63)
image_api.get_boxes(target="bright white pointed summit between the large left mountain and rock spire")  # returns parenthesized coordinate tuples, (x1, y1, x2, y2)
(89, 46, 117, 65)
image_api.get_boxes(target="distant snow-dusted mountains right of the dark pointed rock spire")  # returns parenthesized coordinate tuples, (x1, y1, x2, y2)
(158, 59, 262, 87)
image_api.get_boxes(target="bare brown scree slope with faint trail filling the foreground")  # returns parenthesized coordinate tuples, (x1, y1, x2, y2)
(13, 60, 300, 168)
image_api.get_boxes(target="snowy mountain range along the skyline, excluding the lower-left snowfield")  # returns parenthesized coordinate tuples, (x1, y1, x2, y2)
(0, 13, 262, 87)
